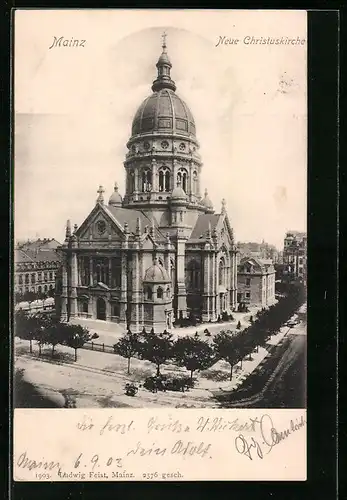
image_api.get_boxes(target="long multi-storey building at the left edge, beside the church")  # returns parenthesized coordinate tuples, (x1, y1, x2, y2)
(14, 238, 60, 295)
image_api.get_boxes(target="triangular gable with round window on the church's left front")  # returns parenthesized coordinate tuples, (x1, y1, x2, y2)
(76, 204, 124, 241)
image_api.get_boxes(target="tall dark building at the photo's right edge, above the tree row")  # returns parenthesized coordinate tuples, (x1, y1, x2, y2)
(283, 231, 307, 283)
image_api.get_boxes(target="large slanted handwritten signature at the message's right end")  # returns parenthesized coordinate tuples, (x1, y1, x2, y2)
(235, 414, 306, 460)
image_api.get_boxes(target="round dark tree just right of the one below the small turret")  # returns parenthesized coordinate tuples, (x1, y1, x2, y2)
(173, 336, 213, 380)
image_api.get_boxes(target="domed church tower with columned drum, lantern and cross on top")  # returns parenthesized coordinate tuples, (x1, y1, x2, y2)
(123, 34, 206, 236)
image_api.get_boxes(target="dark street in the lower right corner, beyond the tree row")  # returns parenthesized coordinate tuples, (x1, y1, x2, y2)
(217, 323, 306, 408)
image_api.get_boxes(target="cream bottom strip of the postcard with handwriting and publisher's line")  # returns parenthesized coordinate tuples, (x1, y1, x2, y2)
(13, 409, 306, 481)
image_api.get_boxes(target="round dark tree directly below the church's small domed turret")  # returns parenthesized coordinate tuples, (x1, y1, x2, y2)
(138, 331, 173, 377)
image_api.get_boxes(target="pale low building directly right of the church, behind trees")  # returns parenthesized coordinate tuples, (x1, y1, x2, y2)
(237, 257, 275, 307)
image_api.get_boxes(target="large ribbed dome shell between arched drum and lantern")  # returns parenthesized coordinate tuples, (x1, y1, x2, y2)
(132, 88, 195, 136)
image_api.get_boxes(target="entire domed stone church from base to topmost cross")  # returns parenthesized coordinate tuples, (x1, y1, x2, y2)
(57, 36, 237, 332)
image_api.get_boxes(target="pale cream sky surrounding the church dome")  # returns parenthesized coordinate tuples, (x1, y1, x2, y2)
(14, 10, 307, 248)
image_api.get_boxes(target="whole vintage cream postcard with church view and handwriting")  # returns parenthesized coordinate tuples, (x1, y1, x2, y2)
(13, 9, 307, 481)
